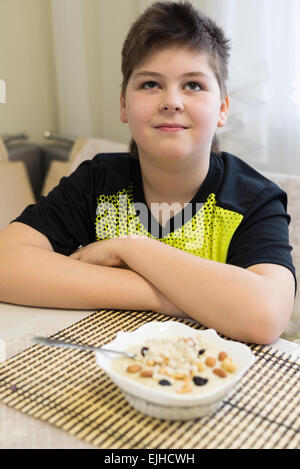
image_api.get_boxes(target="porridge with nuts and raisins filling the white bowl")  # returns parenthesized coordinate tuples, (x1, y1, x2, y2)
(112, 337, 236, 394)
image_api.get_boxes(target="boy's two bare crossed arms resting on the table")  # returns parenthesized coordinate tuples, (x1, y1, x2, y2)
(0, 223, 294, 343)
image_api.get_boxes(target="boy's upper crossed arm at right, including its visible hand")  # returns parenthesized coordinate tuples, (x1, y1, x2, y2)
(71, 237, 294, 343)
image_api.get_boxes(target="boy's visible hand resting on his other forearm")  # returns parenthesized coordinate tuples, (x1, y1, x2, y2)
(70, 238, 127, 268)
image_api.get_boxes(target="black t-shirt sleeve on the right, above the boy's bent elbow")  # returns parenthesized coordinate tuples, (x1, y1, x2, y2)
(227, 182, 297, 291)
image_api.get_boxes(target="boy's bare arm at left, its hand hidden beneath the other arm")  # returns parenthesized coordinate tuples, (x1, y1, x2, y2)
(0, 223, 185, 316)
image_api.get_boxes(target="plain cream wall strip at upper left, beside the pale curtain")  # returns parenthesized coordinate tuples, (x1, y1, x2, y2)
(0, 0, 58, 141)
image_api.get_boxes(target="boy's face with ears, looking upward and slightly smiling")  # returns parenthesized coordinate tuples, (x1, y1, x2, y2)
(121, 46, 229, 165)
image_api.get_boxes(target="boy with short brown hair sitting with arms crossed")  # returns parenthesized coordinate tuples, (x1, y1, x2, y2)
(0, 2, 295, 343)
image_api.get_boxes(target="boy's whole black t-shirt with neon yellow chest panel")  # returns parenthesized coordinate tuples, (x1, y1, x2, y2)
(14, 152, 296, 292)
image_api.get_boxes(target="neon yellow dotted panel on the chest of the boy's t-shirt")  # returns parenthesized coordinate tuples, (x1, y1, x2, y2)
(95, 184, 243, 262)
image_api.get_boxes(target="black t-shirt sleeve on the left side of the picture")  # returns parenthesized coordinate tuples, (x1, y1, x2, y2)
(13, 157, 105, 255)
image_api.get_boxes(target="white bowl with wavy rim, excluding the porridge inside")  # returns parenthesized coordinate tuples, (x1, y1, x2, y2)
(96, 321, 255, 420)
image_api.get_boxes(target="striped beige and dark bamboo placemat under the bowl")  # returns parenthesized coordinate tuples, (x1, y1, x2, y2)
(0, 310, 300, 449)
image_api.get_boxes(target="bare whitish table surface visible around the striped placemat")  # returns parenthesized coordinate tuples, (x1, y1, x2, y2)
(0, 303, 300, 449)
